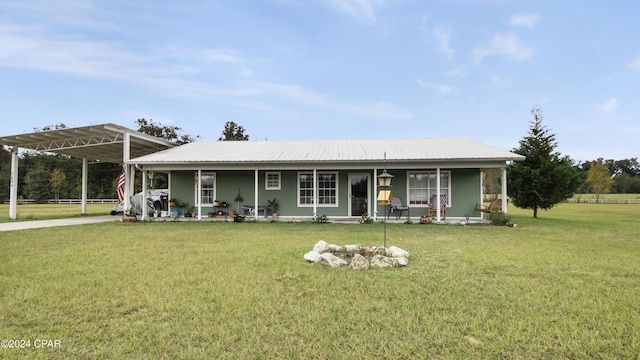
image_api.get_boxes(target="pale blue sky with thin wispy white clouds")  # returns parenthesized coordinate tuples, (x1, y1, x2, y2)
(0, 0, 640, 161)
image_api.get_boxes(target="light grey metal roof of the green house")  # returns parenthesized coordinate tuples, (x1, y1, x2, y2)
(130, 138, 524, 165)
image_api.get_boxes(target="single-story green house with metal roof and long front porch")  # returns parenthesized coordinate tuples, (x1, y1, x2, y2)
(130, 138, 524, 221)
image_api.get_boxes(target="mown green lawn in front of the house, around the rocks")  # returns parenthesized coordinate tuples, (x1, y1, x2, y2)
(0, 204, 640, 359)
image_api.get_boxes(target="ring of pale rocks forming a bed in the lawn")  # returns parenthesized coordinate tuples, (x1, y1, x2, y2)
(304, 240, 409, 270)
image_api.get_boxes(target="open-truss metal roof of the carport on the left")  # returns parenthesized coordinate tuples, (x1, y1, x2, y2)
(0, 124, 175, 163)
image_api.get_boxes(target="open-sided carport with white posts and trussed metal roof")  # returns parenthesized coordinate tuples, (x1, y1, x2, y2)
(0, 124, 175, 220)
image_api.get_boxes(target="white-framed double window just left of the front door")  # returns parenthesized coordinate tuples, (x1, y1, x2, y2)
(298, 173, 338, 206)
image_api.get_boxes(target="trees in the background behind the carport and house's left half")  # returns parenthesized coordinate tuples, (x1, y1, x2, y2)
(0, 118, 249, 202)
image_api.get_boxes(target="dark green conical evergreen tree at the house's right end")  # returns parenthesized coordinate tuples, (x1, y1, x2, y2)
(507, 107, 580, 218)
